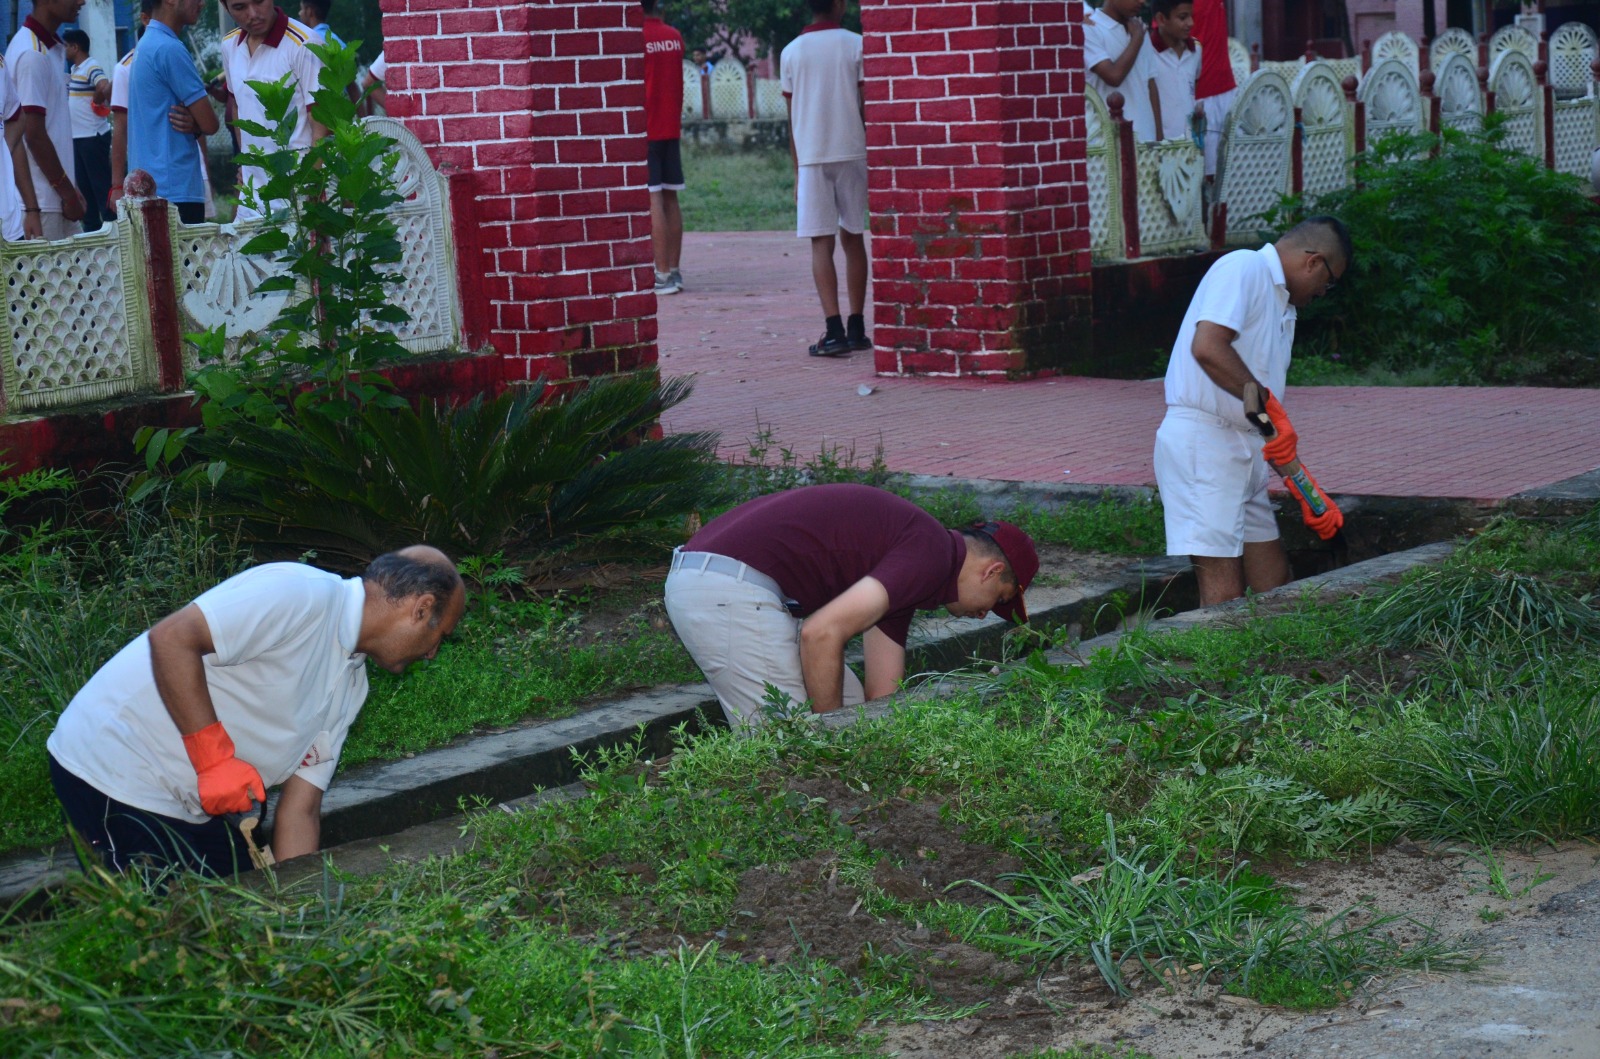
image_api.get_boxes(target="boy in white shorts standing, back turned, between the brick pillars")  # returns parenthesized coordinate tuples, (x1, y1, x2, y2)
(779, 0, 872, 357)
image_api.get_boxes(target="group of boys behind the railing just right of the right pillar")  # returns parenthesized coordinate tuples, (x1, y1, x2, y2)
(1083, 0, 1238, 176)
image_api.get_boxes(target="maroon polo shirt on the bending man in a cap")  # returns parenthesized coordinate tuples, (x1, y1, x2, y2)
(683, 485, 966, 646)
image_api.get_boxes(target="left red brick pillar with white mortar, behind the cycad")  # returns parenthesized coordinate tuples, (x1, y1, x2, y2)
(382, 0, 656, 381)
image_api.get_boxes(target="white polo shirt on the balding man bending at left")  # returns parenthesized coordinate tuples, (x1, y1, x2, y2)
(46, 563, 366, 824)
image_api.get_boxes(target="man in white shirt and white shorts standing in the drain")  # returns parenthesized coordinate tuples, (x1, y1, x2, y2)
(1155, 216, 1354, 606)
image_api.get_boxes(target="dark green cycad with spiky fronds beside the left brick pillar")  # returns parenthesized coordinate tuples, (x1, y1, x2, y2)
(192, 374, 723, 569)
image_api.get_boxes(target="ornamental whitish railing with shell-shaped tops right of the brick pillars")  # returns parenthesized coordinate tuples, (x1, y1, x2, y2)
(1085, 26, 1600, 261)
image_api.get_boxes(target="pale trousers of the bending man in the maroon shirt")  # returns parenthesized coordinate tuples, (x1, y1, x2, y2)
(666, 566, 867, 729)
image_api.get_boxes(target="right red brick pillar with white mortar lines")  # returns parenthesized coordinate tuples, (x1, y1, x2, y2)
(861, 0, 1090, 376)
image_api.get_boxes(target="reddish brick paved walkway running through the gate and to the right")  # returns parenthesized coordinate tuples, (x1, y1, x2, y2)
(661, 232, 1600, 501)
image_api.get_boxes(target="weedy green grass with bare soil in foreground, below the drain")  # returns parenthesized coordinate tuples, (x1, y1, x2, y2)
(12, 515, 1600, 1059)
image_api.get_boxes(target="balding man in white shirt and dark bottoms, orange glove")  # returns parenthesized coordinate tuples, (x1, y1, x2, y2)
(45, 544, 466, 875)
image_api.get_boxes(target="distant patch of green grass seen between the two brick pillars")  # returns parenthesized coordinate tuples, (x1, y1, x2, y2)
(678, 142, 795, 232)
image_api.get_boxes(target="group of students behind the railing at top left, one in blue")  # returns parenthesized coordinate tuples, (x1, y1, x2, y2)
(0, 0, 384, 240)
